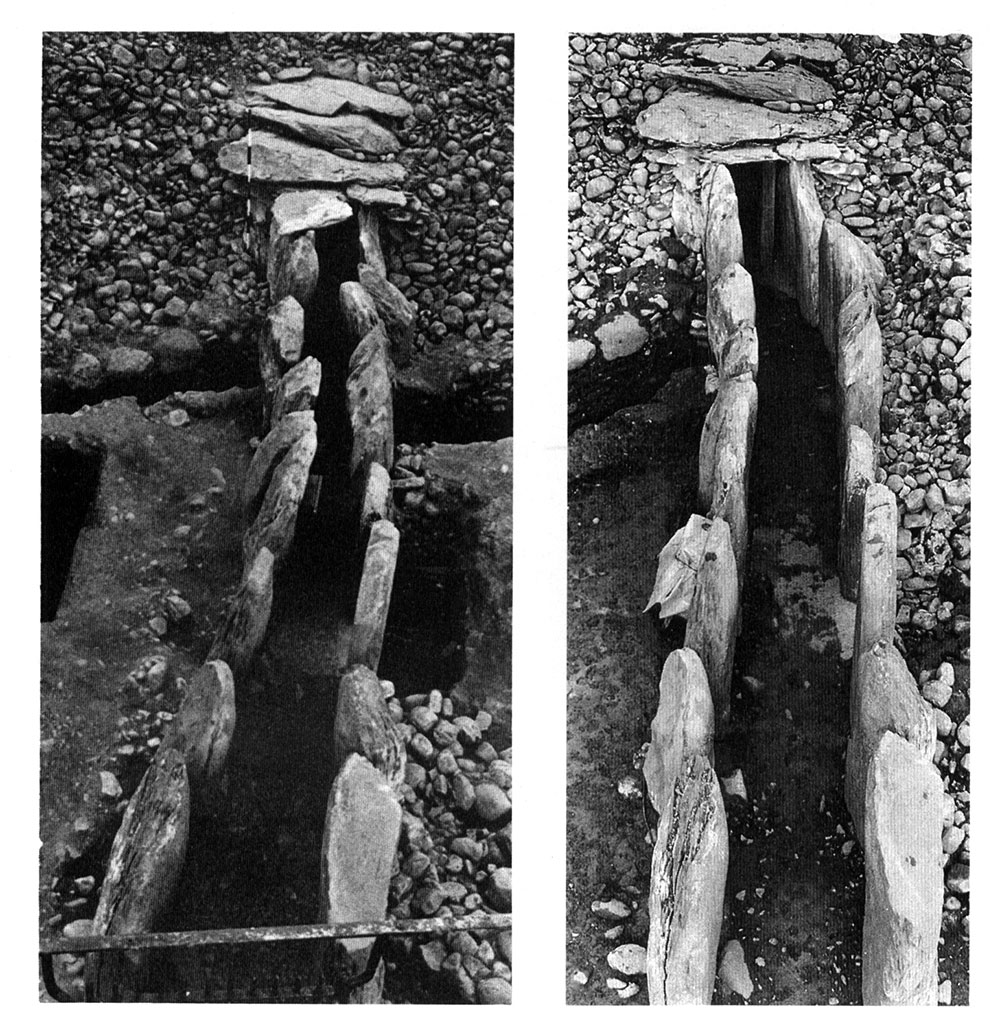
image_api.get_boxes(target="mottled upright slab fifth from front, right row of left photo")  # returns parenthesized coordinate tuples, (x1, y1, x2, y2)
(347, 323, 395, 478)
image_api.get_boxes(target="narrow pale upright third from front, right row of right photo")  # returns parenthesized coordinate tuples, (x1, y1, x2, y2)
(854, 484, 897, 656)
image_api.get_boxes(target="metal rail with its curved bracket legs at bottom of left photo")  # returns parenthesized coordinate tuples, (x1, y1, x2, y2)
(38, 913, 512, 1003)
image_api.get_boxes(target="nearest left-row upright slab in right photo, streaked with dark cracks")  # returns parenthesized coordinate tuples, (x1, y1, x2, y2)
(646, 755, 729, 1005)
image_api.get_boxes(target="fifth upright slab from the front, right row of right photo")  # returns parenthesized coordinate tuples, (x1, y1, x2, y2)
(837, 284, 882, 457)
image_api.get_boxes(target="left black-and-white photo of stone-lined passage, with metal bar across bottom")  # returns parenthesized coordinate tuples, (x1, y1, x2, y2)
(38, 32, 514, 1004)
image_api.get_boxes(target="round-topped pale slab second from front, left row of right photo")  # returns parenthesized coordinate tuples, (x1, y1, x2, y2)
(642, 648, 715, 813)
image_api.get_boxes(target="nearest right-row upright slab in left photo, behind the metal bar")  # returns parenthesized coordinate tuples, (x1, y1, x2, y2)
(321, 753, 402, 970)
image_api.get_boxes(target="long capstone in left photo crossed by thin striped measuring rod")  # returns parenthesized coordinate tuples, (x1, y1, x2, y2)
(219, 132, 407, 187)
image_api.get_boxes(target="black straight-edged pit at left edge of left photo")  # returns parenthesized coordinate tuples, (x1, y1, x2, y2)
(41, 438, 103, 622)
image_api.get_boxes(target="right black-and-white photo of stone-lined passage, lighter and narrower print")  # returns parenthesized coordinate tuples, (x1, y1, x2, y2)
(567, 32, 972, 1006)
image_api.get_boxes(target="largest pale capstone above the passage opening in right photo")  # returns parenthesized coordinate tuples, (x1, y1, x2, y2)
(635, 89, 850, 146)
